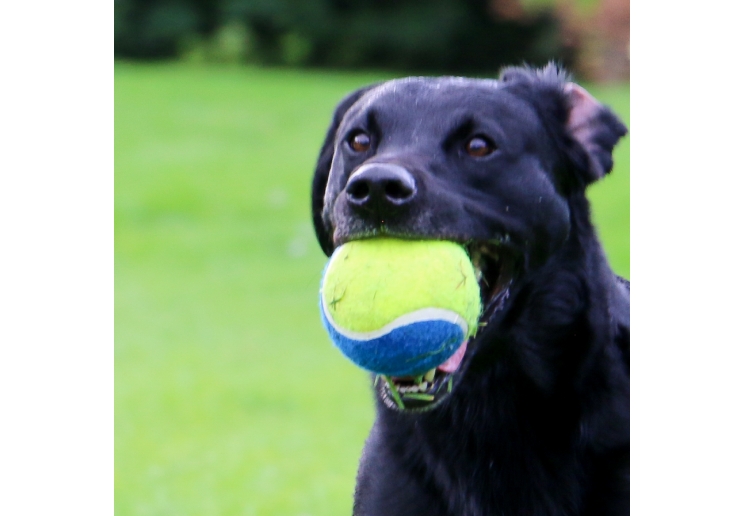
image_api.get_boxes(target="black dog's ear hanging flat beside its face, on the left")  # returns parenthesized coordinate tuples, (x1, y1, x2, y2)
(312, 84, 376, 256)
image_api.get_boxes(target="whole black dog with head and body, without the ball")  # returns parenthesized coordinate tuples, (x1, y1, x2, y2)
(312, 65, 630, 516)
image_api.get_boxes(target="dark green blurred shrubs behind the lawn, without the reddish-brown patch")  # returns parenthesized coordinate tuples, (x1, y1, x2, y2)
(114, 0, 571, 73)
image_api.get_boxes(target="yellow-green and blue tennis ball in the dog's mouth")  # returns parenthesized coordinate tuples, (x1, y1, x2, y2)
(320, 238, 481, 377)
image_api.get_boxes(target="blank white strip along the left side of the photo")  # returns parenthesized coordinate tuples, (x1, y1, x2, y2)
(0, 1, 114, 515)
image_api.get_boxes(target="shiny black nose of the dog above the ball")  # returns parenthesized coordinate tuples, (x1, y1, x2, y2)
(346, 163, 416, 215)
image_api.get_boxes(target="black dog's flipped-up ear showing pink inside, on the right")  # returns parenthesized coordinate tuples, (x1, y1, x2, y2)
(563, 83, 628, 184)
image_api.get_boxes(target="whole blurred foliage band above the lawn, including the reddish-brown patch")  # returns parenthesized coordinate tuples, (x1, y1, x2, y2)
(114, 0, 630, 81)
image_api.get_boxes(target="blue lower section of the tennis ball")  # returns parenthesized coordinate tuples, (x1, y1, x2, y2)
(320, 301, 466, 376)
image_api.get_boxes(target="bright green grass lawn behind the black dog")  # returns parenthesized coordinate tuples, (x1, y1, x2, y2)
(115, 63, 629, 516)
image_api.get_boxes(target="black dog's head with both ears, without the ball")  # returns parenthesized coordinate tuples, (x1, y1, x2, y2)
(312, 65, 626, 412)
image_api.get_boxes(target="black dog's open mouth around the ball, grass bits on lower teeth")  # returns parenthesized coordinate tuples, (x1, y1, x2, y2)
(375, 239, 516, 412)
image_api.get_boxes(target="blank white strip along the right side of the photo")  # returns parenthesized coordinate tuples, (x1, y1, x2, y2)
(630, 1, 744, 516)
